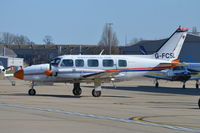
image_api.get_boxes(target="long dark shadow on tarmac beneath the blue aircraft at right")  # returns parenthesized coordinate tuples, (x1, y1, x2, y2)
(84, 86, 200, 96)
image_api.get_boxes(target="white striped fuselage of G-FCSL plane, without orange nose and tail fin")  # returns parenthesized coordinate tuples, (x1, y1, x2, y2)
(24, 55, 170, 82)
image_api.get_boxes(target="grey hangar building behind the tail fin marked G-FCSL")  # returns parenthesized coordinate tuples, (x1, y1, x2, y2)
(120, 34, 200, 62)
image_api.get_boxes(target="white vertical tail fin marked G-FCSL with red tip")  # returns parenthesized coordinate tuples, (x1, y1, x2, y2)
(153, 27, 189, 61)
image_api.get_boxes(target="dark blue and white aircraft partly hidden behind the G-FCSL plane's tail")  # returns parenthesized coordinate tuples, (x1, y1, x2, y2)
(145, 63, 200, 89)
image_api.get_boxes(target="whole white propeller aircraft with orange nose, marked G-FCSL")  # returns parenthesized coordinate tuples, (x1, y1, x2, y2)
(14, 27, 188, 97)
